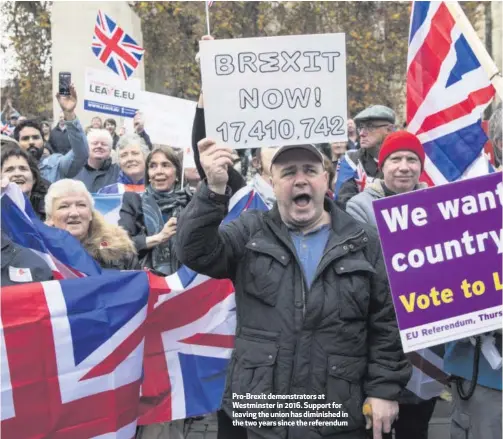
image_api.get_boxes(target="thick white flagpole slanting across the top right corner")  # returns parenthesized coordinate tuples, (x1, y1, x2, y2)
(444, 1, 503, 99)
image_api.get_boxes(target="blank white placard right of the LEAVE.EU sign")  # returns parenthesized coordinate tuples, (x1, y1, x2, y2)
(125, 92, 196, 148)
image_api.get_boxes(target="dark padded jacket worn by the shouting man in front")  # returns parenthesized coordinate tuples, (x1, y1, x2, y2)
(176, 184, 411, 439)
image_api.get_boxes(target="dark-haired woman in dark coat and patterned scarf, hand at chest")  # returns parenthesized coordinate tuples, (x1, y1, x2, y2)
(119, 146, 192, 276)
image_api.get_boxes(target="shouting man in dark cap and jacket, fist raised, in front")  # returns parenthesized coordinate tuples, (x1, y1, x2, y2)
(176, 139, 411, 439)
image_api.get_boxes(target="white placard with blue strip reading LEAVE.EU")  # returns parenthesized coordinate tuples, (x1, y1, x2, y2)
(84, 68, 141, 118)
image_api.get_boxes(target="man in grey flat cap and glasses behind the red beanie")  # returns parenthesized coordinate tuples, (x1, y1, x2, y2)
(335, 105, 396, 209)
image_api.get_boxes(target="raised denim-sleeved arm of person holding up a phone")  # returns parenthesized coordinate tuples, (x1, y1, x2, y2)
(56, 84, 89, 178)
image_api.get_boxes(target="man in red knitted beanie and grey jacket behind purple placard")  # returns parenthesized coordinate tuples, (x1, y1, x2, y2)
(346, 131, 436, 439)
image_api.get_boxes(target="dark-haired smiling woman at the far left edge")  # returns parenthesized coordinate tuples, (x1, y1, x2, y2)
(1, 145, 50, 221)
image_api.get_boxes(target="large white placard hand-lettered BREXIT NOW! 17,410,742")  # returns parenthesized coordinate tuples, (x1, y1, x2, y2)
(200, 34, 347, 149)
